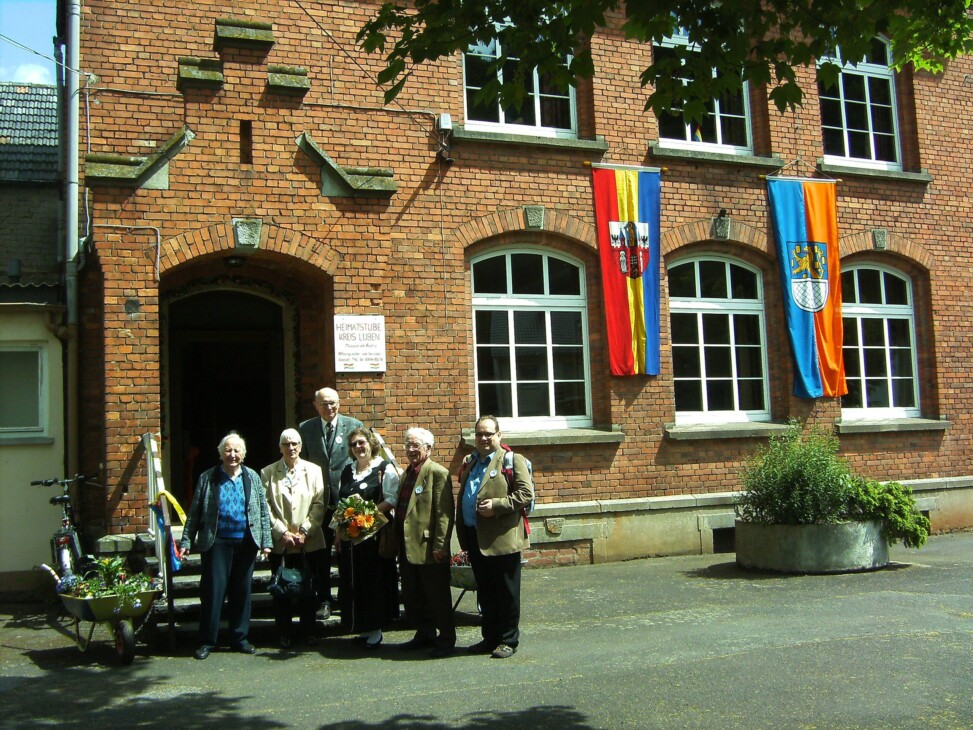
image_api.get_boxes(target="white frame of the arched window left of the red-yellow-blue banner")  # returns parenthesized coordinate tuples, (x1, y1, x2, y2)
(470, 246, 593, 433)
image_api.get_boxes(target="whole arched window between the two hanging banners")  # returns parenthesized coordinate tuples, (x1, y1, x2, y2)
(668, 256, 770, 423)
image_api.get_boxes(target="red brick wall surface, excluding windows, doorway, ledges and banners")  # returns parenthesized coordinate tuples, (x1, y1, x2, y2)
(76, 0, 973, 530)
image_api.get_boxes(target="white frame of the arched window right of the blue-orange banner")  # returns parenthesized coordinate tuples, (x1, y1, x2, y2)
(841, 263, 922, 421)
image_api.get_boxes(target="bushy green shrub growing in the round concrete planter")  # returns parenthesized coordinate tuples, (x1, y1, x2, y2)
(736, 421, 929, 547)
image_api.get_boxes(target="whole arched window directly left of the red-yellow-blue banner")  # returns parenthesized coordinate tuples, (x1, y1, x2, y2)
(472, 249, 592, 431)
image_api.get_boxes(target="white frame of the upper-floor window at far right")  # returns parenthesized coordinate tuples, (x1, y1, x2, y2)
(818, 38, 902, 171)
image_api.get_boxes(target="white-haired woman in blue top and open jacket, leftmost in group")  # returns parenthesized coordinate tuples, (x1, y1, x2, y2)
(179, 433, 272, 659)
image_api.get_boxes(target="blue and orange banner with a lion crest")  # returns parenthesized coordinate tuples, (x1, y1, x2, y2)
(767, 178, 848, 398)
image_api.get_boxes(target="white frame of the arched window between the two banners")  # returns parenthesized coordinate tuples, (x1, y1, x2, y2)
(666, 254, 771, 424)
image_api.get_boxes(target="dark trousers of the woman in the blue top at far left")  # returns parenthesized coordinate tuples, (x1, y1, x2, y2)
(199, 534, 257, 646)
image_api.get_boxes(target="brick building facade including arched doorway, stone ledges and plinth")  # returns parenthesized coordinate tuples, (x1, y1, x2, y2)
(70, 0, 973, 563)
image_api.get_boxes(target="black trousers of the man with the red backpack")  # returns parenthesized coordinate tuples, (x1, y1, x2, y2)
(466, 527, 521, 647)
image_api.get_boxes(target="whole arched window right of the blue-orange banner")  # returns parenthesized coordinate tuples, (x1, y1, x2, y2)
(841, 264, 920, 419)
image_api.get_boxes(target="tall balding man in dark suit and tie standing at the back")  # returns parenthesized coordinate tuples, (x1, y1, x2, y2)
(297, 388, 362, 613)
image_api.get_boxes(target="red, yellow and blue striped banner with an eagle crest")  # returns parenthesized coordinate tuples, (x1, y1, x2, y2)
(591, 167, 661, 375)
